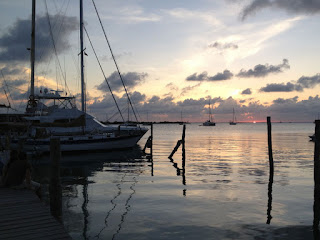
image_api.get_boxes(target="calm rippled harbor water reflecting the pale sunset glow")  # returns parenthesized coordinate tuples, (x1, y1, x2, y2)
(34, 123, 314, 240)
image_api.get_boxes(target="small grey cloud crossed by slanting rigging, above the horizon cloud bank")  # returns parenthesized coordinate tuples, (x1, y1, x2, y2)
(96, 71, 148, 92)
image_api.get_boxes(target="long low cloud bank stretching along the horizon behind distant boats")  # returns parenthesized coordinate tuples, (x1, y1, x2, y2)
(88, 92, 320, 123)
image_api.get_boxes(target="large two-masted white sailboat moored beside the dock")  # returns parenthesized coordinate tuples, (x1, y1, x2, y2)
(11, 0, 148, 153)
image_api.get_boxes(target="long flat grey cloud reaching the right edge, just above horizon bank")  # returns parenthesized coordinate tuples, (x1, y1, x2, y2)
(260, 73, 320, 92)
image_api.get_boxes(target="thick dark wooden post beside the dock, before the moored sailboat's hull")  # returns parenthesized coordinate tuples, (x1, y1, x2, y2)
(49, 138, 62, 221)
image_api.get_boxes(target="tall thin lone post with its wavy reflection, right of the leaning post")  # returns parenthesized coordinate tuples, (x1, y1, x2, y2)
(266, 117, 274, 224)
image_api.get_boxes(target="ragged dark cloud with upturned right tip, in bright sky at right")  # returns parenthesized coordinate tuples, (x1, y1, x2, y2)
(236, 59, 290, 78)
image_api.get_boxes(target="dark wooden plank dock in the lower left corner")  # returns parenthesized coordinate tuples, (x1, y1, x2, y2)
(0, 188, 72, 240)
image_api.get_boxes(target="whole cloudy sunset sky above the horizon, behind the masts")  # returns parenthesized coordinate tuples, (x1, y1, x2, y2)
(0, 0, 320, 122)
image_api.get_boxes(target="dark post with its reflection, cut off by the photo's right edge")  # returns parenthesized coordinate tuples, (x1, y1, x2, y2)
(313, 120, 320, 232)
